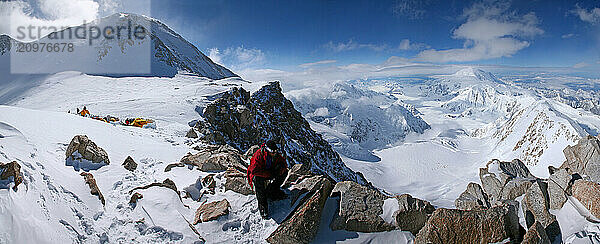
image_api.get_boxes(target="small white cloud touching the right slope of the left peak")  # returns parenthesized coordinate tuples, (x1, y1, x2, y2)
(208, 46, 266, 71)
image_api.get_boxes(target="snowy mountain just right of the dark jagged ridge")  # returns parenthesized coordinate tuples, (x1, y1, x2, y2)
(287, 83, 430, 161)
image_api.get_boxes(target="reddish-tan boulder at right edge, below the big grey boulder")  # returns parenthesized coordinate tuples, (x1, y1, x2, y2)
(571, 180, 600, 219)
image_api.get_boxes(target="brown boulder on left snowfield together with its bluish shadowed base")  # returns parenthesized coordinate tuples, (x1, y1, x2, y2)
(65, 135, 110, 171)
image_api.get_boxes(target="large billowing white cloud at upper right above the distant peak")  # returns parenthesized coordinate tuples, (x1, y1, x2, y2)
(415, 1, 544, 63)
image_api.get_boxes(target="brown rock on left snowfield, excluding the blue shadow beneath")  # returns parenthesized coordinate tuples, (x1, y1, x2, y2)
(65, 135, 110, 164)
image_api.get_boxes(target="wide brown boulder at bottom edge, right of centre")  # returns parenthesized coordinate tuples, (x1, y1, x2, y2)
(415, 201, 522, 244)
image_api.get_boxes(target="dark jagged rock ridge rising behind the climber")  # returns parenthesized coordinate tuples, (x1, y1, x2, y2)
(196, 82, 367, 185)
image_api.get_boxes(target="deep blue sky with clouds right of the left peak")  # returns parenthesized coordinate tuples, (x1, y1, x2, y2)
(144, 0, 600, 70)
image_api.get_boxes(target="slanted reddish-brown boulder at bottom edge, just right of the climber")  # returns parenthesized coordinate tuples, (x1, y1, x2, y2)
(267, 176, 333, 244)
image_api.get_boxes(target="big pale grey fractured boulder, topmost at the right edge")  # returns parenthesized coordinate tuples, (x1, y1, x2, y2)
(560, 136, 600, 183)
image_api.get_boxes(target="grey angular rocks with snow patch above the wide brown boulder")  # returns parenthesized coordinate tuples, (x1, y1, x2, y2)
(479, 159, 536, 206)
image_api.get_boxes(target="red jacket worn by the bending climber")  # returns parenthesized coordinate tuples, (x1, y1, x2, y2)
(247, 144, 288, 187)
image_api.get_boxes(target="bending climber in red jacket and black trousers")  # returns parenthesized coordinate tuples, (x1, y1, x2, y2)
(247, 140, 288, 219)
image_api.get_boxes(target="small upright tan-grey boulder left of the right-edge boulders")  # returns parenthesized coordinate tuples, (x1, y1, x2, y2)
(548, 169, 573, 209)
